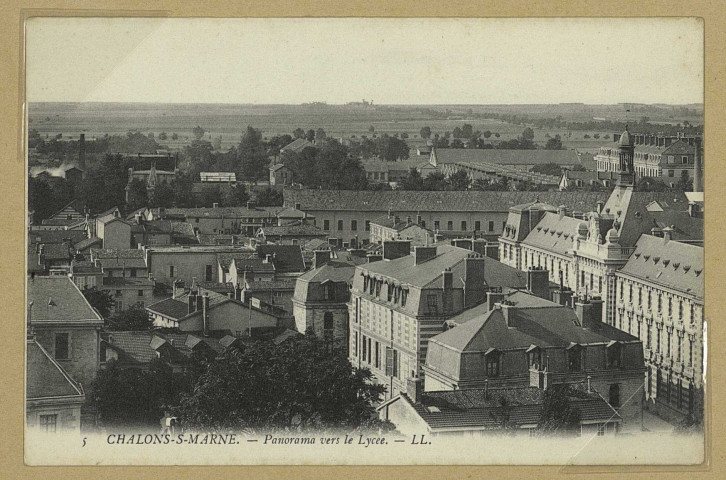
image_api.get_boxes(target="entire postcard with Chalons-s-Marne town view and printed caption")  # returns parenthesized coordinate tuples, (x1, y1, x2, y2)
(25, 17, 713, 465)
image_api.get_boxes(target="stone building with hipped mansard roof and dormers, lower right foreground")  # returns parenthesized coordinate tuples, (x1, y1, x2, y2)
(423, 292, 645, 428)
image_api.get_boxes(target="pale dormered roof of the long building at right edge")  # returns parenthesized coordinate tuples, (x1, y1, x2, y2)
(619, 235, 704, 300)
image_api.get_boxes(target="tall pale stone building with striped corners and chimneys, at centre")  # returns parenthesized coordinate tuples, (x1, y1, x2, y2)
(349, 241, 527, 398)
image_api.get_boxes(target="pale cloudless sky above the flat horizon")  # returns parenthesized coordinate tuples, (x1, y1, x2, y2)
(26, 18, 703, 104)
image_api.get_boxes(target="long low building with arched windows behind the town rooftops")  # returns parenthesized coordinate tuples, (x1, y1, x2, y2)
(284, 189, 609, 246)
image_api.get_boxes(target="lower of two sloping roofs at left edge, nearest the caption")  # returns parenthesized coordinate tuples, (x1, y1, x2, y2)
(25, 339, 85, 402)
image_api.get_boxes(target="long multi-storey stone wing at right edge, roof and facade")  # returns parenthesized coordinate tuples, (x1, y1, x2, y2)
(614, 234, 705, 419)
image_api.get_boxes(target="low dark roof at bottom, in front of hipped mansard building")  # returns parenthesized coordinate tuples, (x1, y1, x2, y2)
(402, 387, 621, 430)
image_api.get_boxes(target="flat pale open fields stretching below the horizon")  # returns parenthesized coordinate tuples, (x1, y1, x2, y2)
(29, 103, 696, 151)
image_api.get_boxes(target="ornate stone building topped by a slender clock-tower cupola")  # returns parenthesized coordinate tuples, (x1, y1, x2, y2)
(499, 126, 703, 324)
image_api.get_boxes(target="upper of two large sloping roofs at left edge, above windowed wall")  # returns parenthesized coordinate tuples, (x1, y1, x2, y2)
(28, 276, 102, 325)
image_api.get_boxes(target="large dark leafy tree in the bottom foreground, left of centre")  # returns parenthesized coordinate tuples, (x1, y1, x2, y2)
(173, 334, 390, 432)
